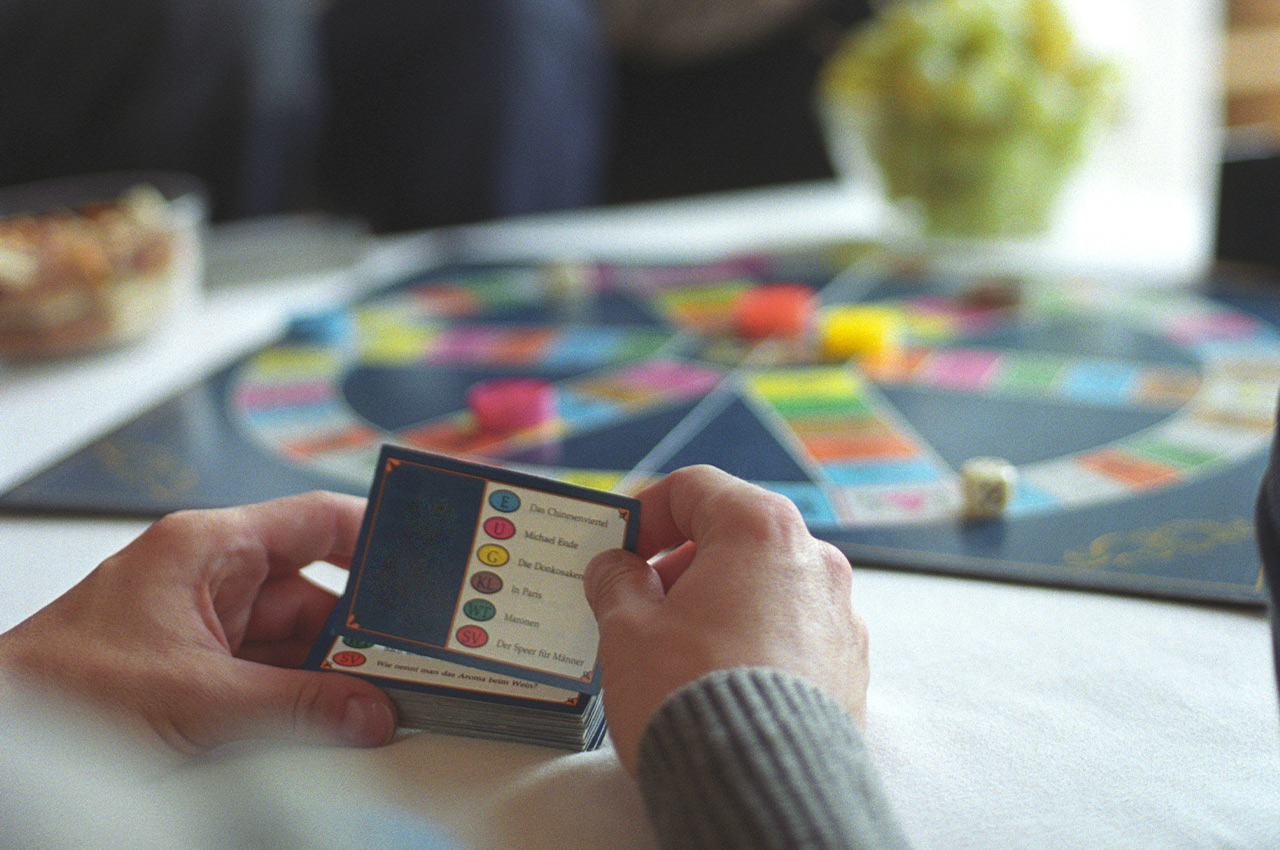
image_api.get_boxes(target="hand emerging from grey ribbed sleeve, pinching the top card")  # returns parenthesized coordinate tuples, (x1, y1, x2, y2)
(584, 466, 869, 773)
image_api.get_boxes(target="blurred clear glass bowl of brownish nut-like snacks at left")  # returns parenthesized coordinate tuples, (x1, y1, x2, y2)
(0, 172, 207, 358)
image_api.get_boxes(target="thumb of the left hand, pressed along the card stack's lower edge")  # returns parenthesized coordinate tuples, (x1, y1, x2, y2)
(192, 662, 396, 746)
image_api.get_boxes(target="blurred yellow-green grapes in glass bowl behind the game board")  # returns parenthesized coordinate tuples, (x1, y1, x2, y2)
(819, 0, 1119, 237)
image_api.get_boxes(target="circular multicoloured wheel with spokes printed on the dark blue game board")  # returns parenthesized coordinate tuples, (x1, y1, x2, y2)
(230, 252, 1280, 529)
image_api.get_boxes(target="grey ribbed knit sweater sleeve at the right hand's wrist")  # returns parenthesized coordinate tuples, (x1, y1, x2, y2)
(639, 668, 909, 850)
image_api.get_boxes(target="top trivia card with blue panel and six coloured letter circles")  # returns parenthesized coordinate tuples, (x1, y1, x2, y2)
(335, 445, 640, 694)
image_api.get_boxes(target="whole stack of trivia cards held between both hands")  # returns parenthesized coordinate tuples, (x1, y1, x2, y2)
(306, 445, 640, 750)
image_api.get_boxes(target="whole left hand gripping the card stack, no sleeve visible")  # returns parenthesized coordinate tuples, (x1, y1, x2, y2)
(0, 493, 396, 753)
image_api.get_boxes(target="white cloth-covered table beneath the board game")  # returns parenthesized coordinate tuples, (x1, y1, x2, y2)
(0, 184, 1280, 850)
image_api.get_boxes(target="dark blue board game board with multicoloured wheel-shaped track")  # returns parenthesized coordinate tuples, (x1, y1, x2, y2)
(0, 246, 1280, 603)
